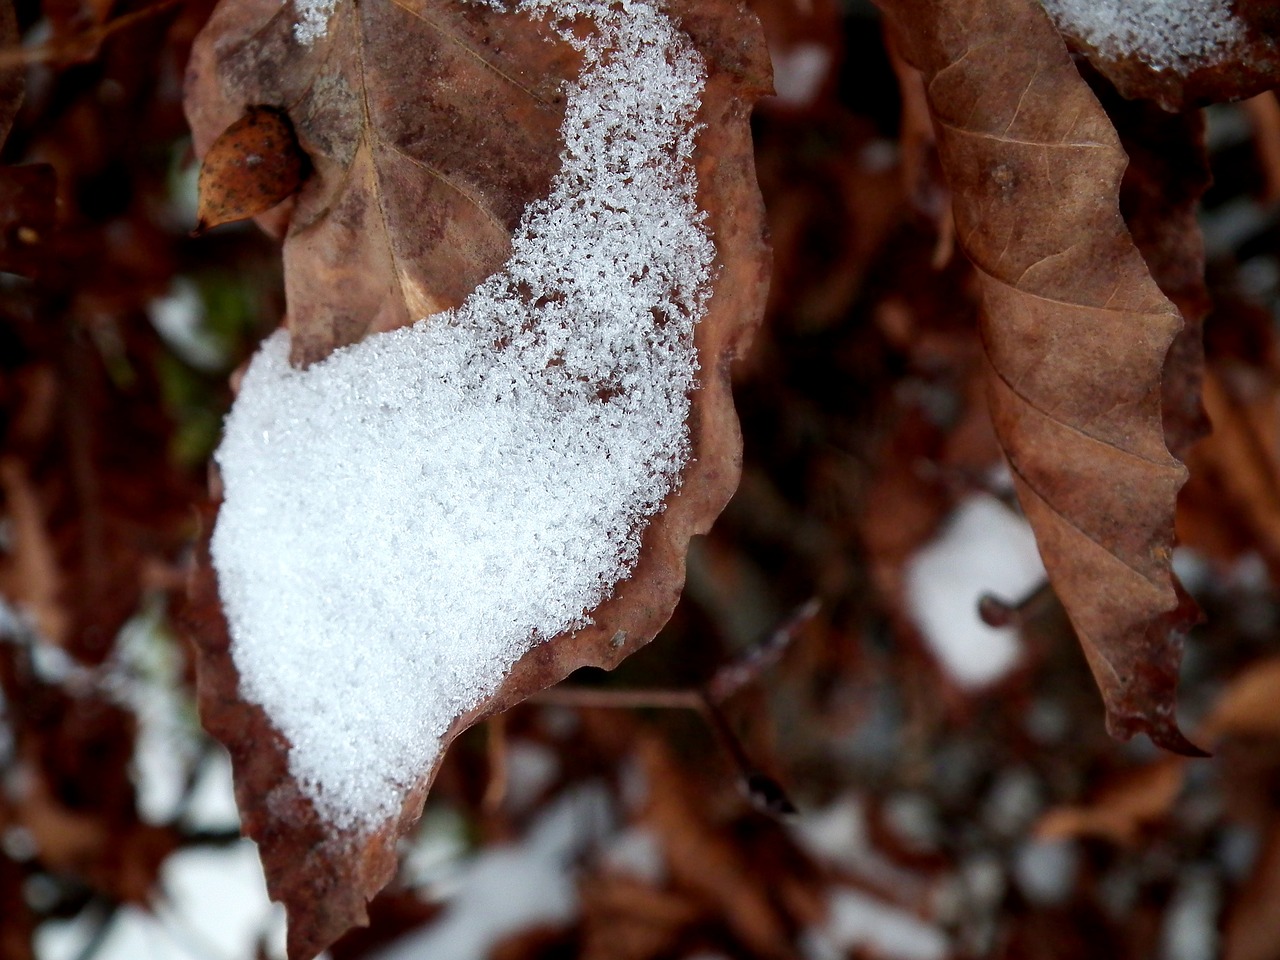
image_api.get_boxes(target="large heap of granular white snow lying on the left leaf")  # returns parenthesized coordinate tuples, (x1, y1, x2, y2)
(212, 0, 714, 829)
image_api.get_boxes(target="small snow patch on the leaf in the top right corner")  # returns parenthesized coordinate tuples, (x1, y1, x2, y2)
(1042, 0, 1243, 70)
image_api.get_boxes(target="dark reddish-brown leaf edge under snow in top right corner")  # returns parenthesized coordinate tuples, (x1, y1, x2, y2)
(1062, 0, 1280, 113)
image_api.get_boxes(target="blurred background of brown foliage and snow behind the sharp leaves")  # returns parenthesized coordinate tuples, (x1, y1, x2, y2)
(0, 0, 1280, 960)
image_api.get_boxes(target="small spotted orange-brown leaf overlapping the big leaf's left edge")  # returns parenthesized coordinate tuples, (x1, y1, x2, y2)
(195, 106, 306, 233)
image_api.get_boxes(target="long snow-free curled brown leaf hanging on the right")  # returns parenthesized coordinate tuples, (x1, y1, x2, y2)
(881, 0, 1196, 751)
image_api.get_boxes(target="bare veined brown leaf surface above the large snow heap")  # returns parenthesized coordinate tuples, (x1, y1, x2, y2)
(187, 0, 577, 364)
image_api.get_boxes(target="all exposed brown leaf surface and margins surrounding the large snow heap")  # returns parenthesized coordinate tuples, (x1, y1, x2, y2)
(187, 0, 768, 957)
